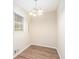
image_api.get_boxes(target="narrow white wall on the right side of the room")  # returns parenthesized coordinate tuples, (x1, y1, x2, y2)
(57, 0, 65, 59)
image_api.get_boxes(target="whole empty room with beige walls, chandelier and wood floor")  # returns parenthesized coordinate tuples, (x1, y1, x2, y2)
(13, 0, 65, 59)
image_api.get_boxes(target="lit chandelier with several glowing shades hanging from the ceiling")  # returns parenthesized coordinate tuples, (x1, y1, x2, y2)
(29, 0, 43, 16)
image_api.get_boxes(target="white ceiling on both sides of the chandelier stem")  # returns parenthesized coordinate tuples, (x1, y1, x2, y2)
(14, 0, 59, 12)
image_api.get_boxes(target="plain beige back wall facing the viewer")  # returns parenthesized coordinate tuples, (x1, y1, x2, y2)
(29, 12, 57, 48)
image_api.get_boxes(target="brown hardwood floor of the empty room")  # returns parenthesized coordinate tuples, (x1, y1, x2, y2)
(14, 45, 59, 59)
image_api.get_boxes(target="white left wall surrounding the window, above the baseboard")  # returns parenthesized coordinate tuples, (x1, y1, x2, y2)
(13, 4, 31, 56)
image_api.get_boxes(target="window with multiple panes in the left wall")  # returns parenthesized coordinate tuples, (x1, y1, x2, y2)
(14, 13, 24, 31)
